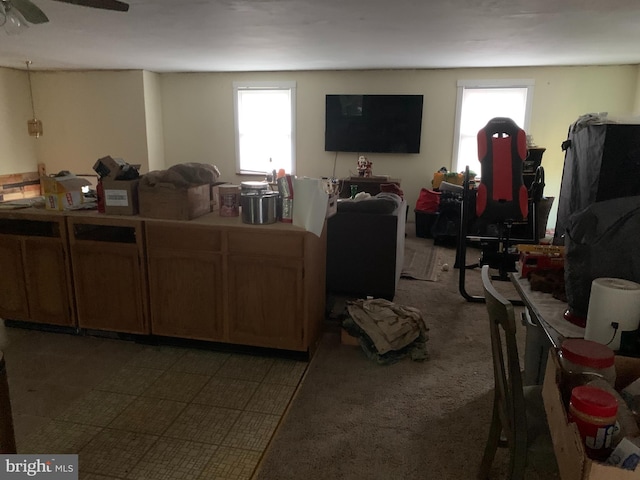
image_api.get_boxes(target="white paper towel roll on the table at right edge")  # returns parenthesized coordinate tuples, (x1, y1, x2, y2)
(584, 277, 640, 350)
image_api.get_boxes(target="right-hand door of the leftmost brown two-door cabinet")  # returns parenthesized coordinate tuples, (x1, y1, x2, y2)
(24, 237, 75, 326)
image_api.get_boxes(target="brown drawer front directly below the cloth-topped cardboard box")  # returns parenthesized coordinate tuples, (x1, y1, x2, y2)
(145, 222, 222, 252)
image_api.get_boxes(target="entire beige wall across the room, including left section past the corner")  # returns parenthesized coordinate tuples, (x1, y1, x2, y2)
(0, 66, 640, 231)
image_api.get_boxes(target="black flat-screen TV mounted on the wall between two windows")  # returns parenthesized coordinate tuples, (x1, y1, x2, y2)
(324, 95, 423, 153)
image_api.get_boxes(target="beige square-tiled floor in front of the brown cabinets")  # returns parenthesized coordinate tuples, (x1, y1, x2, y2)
(0, 320, 308, 480)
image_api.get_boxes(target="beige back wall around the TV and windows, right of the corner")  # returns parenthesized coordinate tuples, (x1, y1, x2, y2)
(162, 66, 638, 226)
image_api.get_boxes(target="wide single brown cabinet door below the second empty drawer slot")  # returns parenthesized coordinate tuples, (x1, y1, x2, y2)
(71, 242, 149, 334)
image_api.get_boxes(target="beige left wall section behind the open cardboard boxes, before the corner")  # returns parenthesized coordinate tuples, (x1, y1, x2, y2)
(33, 71, 149, 174)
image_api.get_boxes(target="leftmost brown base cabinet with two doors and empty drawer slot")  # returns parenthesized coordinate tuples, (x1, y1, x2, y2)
(0, 210, 76, 327)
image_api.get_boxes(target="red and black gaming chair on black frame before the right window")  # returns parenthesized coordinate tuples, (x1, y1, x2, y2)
(456, 117, 537, 301)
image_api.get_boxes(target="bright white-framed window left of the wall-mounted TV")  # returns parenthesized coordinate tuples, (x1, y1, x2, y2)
(233, 82, 296, 174)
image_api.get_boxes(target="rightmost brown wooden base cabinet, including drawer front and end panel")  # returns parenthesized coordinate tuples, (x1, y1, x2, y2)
(227, 229, 326, 351)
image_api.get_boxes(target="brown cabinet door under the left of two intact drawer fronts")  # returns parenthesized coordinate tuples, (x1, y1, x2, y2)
(148, 250, 224, 341)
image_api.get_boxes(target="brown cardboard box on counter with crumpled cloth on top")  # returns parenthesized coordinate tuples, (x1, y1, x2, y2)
(138, 183, 211, 220)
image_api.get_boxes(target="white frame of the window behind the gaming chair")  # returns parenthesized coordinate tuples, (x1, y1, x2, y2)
(451, 79, 535, 174)
